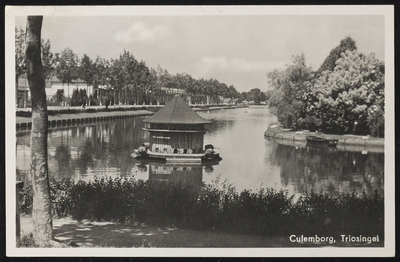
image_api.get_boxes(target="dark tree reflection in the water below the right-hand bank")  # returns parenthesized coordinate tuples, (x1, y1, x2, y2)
(269, 142, 384, 194)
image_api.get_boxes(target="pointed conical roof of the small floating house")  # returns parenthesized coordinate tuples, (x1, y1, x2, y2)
(143, 95, 212, 125)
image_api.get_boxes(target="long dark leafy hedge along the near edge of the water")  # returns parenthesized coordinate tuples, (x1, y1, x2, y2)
(20, 178, 384, 239)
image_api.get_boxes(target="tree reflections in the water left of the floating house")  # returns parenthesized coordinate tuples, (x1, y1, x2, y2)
(16, 118, 147, 179)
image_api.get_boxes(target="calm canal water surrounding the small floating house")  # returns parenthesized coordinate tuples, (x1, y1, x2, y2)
(16, 106, 384, 195)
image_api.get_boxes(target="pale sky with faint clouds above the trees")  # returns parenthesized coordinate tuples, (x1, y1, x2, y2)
(15, 15, 385, 92)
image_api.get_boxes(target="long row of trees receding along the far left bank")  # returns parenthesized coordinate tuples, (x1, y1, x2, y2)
(15, 28, 241, 104)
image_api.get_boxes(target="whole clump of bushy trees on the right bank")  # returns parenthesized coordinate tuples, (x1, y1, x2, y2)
(267, 37, 385, 137)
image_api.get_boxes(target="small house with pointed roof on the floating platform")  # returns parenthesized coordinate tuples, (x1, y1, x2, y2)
(143, 95, 212, 154)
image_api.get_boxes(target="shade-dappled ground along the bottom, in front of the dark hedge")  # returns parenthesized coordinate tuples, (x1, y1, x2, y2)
(21, 215, 383, 248)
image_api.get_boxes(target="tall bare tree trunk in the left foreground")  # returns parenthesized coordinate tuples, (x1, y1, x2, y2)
(26, 16, 53, 246)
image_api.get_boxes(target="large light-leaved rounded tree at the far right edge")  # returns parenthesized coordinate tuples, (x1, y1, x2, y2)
(307, 50, 385, 136)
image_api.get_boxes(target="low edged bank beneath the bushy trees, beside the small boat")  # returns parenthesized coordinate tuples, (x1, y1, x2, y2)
(264, 125, 385, 152)
